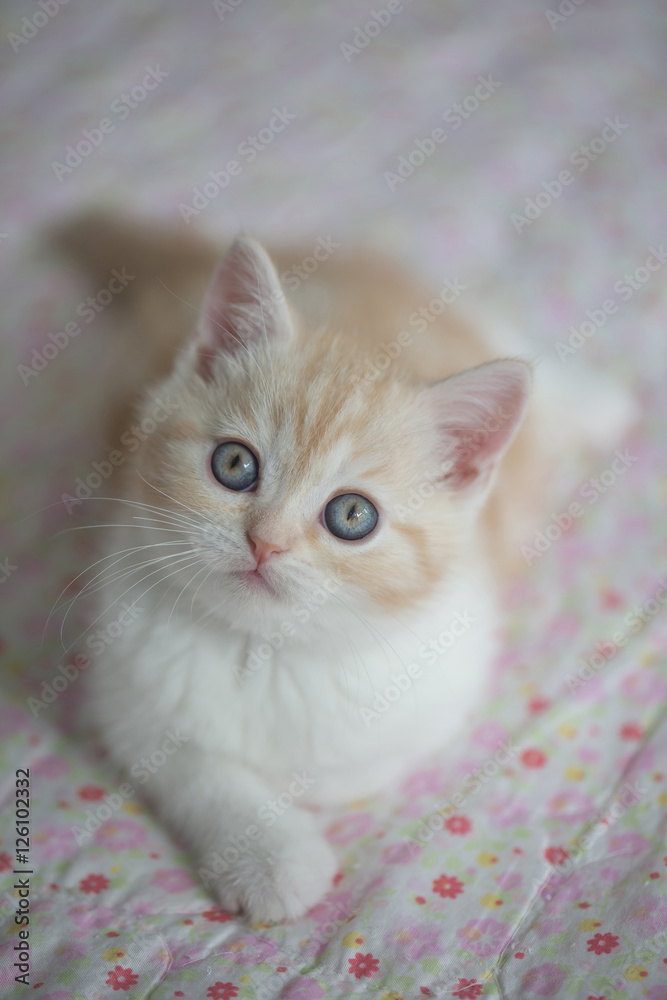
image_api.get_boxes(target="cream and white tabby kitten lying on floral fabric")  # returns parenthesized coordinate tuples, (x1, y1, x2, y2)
(56, 215, 628, 921)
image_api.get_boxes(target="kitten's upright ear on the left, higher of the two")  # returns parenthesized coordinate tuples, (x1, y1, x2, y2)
(192, 236, 292, 380)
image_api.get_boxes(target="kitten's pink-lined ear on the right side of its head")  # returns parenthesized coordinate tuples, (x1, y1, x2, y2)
(426, 360, 531, 500)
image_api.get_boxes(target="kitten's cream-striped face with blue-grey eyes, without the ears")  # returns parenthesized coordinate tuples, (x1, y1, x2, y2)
(138, 340, 462, 625)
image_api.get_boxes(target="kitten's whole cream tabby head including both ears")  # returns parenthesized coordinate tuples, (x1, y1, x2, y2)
(131, 238, 529, 628)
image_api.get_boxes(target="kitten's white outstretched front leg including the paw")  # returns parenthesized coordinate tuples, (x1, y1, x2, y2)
(139, 746, 336, 922)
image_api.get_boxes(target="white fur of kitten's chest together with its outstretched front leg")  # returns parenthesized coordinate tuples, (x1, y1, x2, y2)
(90, 532, 496, 920)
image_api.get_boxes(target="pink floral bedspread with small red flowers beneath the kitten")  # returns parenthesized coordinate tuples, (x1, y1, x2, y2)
(0, 0, 667, 1000)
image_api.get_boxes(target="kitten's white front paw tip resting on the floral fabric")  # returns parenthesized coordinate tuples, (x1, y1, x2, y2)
(211, 808, 337, 923)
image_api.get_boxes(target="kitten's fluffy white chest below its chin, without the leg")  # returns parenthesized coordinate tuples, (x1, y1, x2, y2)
(92, 564, 496, 805)
